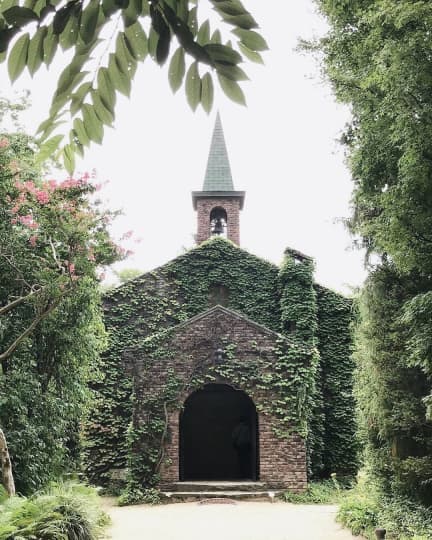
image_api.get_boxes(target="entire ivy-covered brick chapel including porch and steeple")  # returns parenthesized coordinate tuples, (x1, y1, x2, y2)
(84, 115, 357, 491)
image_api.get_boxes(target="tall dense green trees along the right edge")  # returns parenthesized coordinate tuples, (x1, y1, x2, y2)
(317, 0, 432, 504)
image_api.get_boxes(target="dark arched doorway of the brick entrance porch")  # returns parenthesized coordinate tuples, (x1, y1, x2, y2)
(180, 384, 259, 481)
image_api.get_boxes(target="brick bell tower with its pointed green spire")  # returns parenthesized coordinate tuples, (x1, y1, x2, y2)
(192, 113, 245, 246)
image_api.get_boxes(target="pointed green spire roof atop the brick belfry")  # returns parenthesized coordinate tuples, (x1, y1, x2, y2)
(203, 112, 234, 191)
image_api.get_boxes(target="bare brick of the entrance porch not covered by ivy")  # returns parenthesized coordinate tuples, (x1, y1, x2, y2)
(133, 307, 307, 492)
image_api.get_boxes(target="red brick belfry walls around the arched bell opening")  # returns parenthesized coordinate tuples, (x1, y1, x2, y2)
(196, 197, 240, 246)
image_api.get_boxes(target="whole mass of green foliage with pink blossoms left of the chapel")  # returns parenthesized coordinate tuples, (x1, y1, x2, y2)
(0, 104, 118, 494)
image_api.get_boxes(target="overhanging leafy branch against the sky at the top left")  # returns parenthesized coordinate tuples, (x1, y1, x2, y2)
(0, 0, 267, 172)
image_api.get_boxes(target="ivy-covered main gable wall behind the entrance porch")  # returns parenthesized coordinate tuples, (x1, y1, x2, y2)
(84, 238, 356, 485)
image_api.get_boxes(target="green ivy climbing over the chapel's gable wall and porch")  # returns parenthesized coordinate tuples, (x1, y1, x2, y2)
(84, 238, 356, 489)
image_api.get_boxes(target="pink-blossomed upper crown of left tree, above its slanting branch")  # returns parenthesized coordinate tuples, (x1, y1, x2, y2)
(0, 134, 124, 371)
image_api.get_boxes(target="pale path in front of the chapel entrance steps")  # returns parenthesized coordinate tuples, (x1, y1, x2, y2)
(102, 501, 355, 540)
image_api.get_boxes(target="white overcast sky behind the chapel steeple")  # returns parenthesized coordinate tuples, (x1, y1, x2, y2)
(0, 0, 365, 292)
